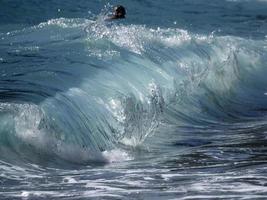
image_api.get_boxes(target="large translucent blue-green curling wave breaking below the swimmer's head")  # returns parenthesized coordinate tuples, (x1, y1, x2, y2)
(0, 18, 267, 164)
